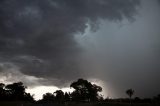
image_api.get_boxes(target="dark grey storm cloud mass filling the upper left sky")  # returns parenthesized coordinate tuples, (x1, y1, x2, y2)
(0, 0, 139, 85)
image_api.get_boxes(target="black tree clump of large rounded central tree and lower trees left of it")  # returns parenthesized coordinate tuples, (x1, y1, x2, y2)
(35, 79, 102, 103)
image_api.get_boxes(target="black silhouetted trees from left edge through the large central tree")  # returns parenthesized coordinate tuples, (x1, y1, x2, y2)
(0, 79, 102, 103)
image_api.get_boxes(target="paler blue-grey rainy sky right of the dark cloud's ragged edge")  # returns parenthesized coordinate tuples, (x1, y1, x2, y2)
(77, 0, 160, 97)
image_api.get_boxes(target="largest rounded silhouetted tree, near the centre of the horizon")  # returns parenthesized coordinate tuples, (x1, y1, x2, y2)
(70, 79, 102, 102)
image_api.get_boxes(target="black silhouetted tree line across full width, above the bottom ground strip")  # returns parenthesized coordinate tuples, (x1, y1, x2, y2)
(0, 79, 160, 104)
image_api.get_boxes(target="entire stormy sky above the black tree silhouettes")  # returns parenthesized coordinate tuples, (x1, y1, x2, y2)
(0, 0, 160, 98)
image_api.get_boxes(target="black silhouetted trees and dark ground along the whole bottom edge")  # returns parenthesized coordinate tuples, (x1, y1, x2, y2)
(0, 79, 160, 106)
